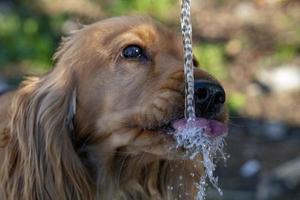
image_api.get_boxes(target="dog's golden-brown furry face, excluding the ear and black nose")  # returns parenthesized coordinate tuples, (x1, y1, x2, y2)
(57, 17, 227, 161)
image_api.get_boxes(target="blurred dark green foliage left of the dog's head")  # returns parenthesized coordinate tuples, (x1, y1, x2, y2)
(0, 7, 65, 69)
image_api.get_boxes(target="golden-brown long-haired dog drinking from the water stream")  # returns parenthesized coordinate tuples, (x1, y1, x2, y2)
(0, 16, 228, 200)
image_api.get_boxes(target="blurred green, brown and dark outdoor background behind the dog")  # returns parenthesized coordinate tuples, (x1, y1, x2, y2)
(0, 0, 300, 200)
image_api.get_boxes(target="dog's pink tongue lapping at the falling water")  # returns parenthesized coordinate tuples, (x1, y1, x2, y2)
(173, 118, 227, 138)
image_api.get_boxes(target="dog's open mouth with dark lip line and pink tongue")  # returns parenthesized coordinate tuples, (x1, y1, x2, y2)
(151, 117, 227, 139)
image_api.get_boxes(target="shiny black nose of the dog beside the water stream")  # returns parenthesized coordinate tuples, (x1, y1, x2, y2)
(194, 80, 225, 118)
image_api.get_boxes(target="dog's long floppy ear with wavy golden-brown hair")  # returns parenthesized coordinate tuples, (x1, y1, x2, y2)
(1, 68, 92, 200)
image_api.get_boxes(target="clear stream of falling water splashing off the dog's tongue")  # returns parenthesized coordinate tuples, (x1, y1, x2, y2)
(179, 0, 225, 200)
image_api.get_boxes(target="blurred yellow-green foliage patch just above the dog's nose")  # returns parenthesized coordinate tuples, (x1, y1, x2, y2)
(193, 43, 227, 79)
